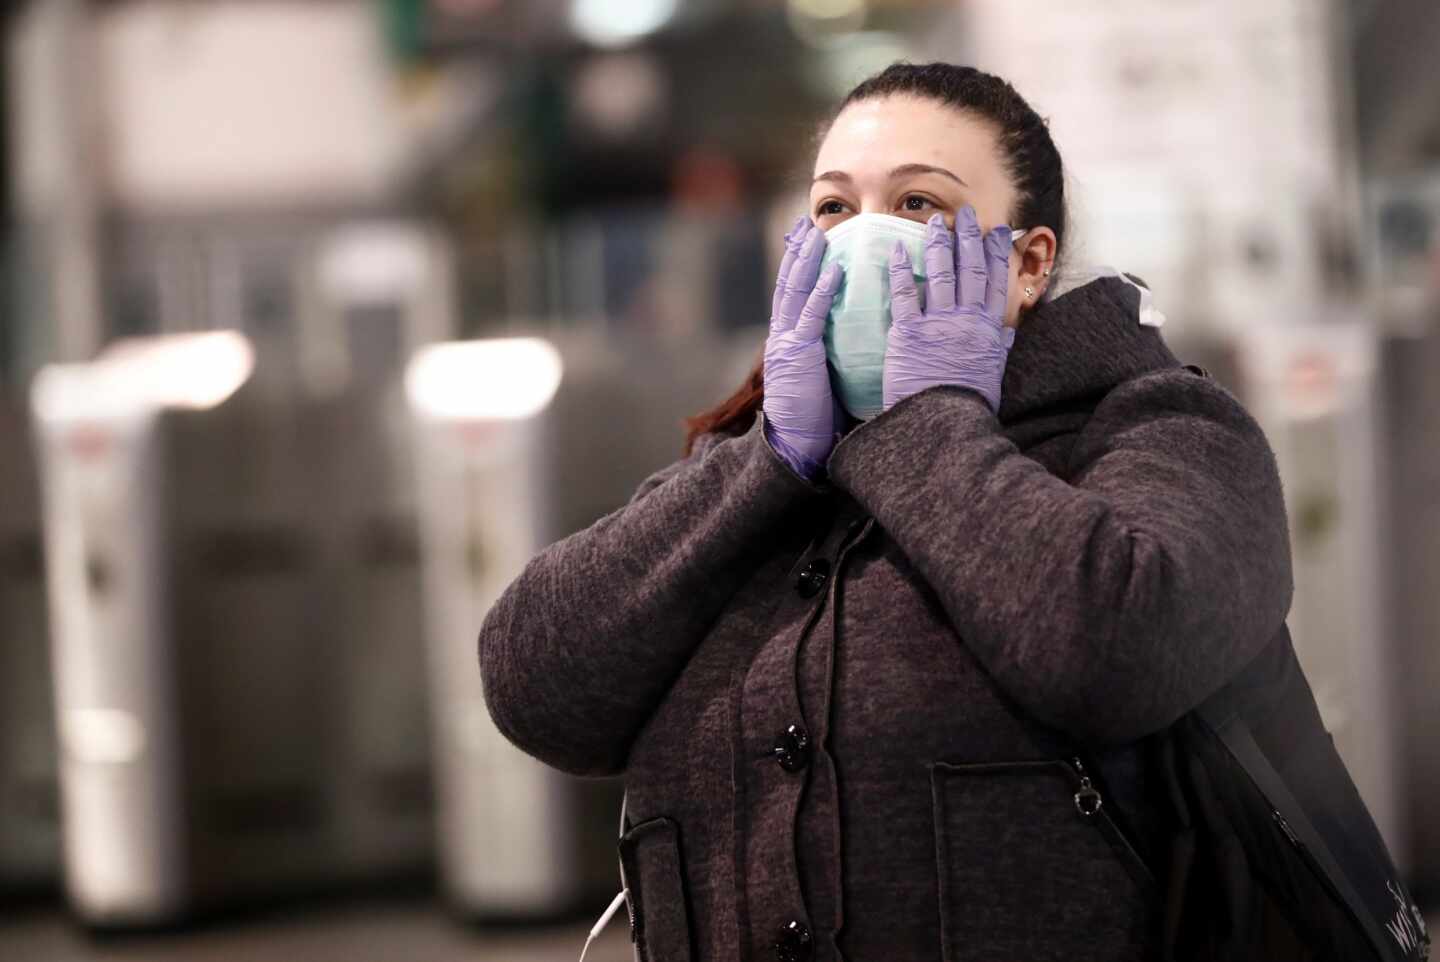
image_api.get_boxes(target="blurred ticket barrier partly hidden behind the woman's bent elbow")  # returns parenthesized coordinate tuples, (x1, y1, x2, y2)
(406, 334, 756, 917)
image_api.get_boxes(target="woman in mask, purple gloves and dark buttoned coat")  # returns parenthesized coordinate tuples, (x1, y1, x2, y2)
(480, 63, 1292, 962)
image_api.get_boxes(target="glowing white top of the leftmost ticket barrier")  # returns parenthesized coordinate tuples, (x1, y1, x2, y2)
(32, 331, 255, 422)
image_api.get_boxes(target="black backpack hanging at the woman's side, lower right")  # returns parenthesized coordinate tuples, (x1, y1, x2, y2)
(1152, 364, 1430, 962)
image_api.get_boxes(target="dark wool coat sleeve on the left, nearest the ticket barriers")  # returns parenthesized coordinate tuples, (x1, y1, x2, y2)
(478, 413, 829, 775)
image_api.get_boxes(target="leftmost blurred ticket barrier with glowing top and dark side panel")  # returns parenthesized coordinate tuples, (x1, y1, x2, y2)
(32, 333, 432, 926)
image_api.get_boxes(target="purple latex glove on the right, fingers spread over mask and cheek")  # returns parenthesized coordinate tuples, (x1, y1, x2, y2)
(883, 204, 1015, 412)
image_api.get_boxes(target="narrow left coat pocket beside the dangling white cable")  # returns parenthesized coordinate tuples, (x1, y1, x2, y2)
(619, 817, 694, 962)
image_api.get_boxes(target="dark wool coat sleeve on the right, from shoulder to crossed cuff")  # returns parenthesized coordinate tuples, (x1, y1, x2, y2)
(828, 369, 1293, 746)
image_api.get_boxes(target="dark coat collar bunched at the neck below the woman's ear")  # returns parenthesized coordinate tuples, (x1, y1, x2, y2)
(999, 270, 1181, 425)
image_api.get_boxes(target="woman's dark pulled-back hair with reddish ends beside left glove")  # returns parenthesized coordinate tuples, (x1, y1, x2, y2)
(684, 63, 1066, 455)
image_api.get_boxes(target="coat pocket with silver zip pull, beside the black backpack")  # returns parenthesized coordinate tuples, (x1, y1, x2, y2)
(930, 759, 1159, 962)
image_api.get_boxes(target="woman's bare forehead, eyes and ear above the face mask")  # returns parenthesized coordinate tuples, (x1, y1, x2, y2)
(809, 95, 1056, 327)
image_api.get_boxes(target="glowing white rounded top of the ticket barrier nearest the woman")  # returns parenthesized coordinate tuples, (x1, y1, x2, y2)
(405, 337, 562, 421)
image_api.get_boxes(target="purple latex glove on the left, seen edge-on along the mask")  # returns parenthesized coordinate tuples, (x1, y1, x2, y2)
(763, 216, 844, 480)
